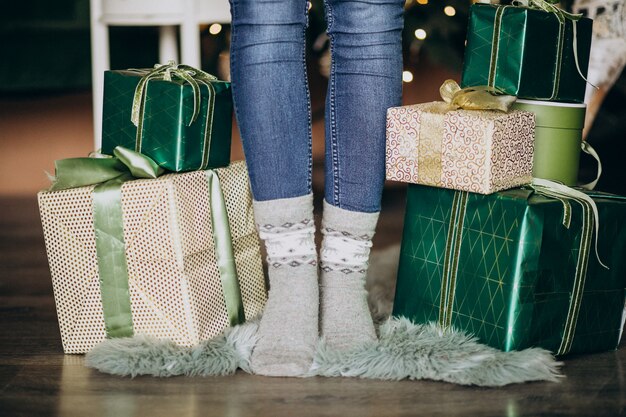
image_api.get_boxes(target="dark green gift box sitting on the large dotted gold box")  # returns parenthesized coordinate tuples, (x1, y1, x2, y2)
(102, 66, 233, 172)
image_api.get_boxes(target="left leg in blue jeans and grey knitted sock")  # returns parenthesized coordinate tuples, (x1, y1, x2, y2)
(231, 0, 319, 376)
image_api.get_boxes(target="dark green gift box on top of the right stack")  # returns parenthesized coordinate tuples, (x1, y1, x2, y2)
(461, 4, 592, 103)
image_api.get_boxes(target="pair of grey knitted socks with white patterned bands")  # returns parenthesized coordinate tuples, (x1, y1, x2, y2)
(251, 194, 378, 376)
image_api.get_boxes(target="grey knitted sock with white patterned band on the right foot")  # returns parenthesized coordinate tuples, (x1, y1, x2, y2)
(320, 201, 378, 349)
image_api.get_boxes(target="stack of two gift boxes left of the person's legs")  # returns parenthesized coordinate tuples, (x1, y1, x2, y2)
(39, 63, 266, 353)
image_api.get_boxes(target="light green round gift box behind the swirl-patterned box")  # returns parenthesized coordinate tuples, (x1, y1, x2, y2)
(513, 100, 587, 185)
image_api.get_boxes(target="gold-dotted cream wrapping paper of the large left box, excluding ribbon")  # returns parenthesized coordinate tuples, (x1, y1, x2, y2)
(38, 162, 266, 353)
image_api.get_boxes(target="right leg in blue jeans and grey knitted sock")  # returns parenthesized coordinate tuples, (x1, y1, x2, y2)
(320, 0, 404, 348)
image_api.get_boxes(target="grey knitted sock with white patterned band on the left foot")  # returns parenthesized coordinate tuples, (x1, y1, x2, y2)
(250, 194, 319, 376)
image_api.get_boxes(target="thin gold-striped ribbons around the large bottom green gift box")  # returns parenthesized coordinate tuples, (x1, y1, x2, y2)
(439, 179, 608, 355)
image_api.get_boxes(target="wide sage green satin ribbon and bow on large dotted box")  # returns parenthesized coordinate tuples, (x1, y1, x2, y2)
(49, 146, 245, 338)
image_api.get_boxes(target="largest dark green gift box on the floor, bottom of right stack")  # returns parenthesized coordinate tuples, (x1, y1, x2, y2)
(393, 184, 626, 355)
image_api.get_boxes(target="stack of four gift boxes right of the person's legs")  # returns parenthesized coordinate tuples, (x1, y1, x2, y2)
(386, 4, 626, 355)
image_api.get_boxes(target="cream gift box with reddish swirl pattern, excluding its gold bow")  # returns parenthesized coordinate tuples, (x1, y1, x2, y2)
(386, 101, 535, 194)
